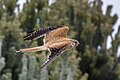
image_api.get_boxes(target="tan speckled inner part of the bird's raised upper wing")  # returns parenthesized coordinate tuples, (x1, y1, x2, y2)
(44, 26, 69, 44)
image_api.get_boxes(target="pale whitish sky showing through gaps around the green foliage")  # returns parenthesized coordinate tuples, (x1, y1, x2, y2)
(15, 0, 120, 55)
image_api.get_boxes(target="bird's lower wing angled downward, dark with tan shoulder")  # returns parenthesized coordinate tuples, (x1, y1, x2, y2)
(41, 41, 70, 68)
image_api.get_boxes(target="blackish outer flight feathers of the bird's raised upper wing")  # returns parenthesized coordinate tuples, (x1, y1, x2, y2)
(23, 25, 63, 40)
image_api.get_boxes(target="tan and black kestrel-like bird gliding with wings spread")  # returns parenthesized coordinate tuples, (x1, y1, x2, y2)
(16, 25, 79, 68)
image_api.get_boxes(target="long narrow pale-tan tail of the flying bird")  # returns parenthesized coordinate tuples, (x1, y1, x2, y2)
(16, 46, 48, 52)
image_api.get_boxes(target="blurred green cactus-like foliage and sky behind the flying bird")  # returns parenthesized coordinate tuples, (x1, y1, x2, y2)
(0, 0, 120, 80)
